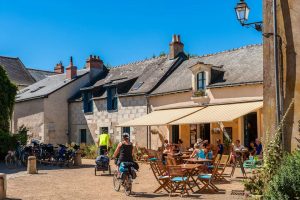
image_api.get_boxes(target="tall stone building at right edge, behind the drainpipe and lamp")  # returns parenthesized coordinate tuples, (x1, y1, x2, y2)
(263, 0, 300, 151)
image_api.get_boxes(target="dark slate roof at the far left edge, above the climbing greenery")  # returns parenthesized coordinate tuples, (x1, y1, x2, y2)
(0, 56, 36, 86)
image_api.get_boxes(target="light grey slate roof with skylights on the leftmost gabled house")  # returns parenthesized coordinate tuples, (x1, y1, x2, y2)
(16, 69, 89, 102)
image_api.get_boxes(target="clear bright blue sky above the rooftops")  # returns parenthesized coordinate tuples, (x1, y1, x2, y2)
(0, 0, 262, 70)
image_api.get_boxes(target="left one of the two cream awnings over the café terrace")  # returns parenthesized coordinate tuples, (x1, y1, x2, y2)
(118, 107, 202, 127)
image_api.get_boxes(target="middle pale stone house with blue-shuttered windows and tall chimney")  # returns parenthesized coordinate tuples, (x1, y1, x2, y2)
(69, 36, 186, 146)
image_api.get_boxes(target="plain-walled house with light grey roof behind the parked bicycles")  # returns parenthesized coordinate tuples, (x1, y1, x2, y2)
(13, 58, 105, 143)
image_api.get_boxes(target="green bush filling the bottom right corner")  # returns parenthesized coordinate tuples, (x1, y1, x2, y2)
(265, 151, 300, 200)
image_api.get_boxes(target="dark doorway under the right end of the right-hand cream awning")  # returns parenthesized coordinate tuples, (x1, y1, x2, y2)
(244, 112, 257, 147)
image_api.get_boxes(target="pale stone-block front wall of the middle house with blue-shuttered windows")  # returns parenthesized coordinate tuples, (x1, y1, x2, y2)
(70, 96, 147, 146)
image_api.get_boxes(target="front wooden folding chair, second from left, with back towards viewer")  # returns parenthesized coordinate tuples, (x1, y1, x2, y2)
(168, 166, 190, 196)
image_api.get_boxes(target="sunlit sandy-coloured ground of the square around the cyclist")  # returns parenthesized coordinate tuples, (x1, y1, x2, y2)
(0, 160, 243, 200)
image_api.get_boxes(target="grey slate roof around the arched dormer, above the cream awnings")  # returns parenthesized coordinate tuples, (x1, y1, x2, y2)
(151, 45, 263, 95)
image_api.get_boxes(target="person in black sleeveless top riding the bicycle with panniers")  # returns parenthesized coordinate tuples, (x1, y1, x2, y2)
(113, 133, 134, 167)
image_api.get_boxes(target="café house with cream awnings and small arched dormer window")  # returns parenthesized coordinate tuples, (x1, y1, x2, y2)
(120, 45, 263, 148)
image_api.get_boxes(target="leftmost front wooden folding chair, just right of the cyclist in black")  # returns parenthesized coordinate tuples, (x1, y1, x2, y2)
(150, 161, 171, 193)
